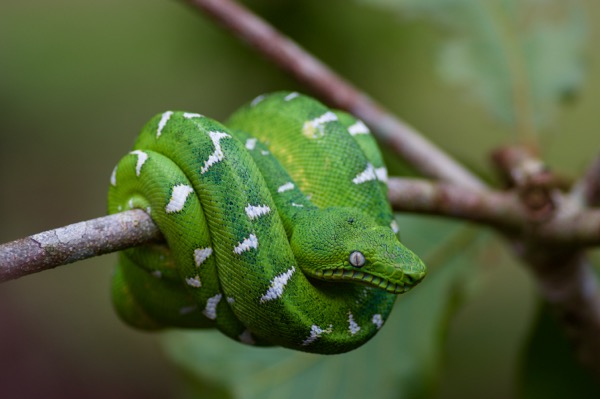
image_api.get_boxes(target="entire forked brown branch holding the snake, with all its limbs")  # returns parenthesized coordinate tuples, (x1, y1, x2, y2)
(0, 0, 600, 382)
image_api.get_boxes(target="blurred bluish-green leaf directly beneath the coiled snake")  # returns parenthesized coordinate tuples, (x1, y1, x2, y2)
(165, 217, 482, 398)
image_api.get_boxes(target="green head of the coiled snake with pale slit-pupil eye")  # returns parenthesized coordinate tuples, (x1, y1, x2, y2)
(290, 207, 426, 294)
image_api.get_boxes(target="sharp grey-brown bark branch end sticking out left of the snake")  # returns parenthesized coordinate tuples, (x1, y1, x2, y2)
(0, 209, 162, 282)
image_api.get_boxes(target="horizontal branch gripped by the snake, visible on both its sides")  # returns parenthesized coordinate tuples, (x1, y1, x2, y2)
(0, 177, 600, 281)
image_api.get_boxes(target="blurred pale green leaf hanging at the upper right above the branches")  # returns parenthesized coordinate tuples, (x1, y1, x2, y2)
(360, 0, 586, 137)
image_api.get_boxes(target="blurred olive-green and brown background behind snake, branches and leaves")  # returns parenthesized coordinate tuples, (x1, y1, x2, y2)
(0, 0, 600, 398)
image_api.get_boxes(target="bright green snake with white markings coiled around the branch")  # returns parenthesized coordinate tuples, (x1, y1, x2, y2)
(108, 92, 425, 354)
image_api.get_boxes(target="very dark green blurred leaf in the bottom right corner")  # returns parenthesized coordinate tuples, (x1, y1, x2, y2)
(519, 306, 600, 399)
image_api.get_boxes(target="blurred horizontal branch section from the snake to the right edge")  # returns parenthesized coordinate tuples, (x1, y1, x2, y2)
(388, 178, 600, 248)
